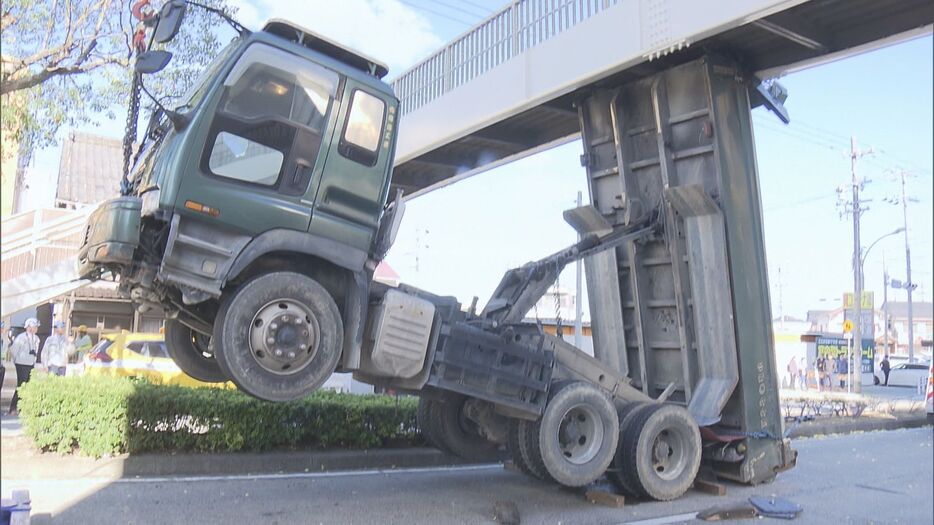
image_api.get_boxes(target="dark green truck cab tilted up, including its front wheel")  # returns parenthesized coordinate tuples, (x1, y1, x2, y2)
(78, 20, 402, 400)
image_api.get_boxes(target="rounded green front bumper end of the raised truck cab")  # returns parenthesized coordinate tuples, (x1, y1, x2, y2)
(77, 197, 142, 279)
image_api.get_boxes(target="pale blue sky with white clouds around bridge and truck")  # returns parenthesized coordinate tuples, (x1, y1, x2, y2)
(18, 0, 934, 318)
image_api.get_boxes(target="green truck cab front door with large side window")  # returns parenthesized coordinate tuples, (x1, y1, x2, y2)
(176, 43, 340, 234)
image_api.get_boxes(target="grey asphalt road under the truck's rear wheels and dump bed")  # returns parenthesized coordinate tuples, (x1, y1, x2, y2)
(2, 427, 934, 525)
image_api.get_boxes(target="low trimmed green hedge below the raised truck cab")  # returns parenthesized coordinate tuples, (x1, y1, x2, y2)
(20, 376, 423, 457)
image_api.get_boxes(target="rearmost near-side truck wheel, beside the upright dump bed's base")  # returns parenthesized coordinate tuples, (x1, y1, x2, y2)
(619, 404, 701, 501)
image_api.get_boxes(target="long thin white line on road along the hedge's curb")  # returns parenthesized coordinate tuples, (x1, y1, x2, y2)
(3, 463, 503, 485)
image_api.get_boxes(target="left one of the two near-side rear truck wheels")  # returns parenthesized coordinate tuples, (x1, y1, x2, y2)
(538, 381, 619, 487)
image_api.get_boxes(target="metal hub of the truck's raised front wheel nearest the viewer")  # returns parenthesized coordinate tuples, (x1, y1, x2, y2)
(250, 299, 318, 375)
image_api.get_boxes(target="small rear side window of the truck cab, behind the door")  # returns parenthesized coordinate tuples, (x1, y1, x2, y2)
(338, 89, 386, 166)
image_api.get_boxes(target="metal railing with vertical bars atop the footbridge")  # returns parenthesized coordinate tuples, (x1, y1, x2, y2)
(392, 0, 621, 115)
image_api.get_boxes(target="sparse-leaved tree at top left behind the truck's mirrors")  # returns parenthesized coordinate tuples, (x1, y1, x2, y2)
(0, 0, 229, 156)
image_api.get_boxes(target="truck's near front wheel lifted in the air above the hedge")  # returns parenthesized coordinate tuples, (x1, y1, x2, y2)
(214, 272, 344, 401)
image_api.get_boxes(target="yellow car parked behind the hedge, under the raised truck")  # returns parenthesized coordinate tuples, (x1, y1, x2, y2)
(84, 330, 236, 389)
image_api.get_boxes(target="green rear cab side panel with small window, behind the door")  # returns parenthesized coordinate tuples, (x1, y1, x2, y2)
(309, 79, 396, 250)
